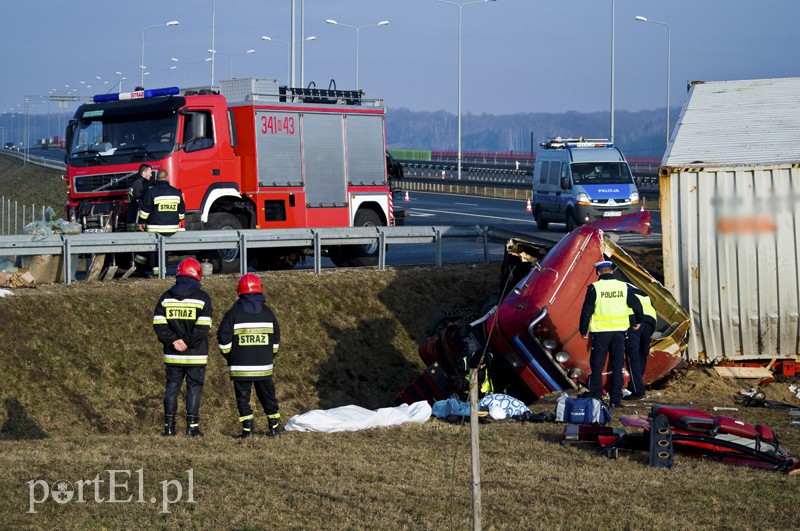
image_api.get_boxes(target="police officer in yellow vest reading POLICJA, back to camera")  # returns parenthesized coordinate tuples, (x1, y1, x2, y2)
(579, 260, 643, 407)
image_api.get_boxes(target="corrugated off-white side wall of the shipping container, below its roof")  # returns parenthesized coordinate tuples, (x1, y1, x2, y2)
(660, 164, 800, 360)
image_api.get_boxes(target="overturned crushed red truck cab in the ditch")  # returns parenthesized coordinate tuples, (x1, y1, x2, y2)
(397, 212, 689, 403)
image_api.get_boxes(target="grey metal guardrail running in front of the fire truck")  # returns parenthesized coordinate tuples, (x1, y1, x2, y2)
(0, 225, 553, 284)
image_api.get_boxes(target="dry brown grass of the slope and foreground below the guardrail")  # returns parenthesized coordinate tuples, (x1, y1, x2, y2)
(0, 153, 800, 530)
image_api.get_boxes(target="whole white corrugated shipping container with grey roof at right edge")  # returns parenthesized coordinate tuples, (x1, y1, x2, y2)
(660, 78, 800, 361)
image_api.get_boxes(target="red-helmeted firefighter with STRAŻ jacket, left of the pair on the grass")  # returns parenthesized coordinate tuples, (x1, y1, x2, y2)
(153, 258, 212, 437)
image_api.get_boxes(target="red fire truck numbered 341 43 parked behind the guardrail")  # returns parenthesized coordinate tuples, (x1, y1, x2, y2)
(66, 78, 404, 273)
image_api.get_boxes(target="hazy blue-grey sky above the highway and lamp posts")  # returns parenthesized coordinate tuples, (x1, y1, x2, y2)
(0, 0, 800, 114)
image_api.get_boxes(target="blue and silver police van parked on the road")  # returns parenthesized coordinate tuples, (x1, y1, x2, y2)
(532, 137, 641, 231)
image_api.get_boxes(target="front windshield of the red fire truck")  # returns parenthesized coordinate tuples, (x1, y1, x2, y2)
(67, 112, 178, 166)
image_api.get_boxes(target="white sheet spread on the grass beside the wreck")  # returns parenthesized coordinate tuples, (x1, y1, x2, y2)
(286, 400, 431, 433)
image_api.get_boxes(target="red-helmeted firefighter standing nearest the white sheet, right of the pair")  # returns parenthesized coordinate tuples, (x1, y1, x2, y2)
(217, 273, 283, 439)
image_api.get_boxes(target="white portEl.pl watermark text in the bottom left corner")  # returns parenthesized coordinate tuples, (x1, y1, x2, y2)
(25, 468, 195, 513)
